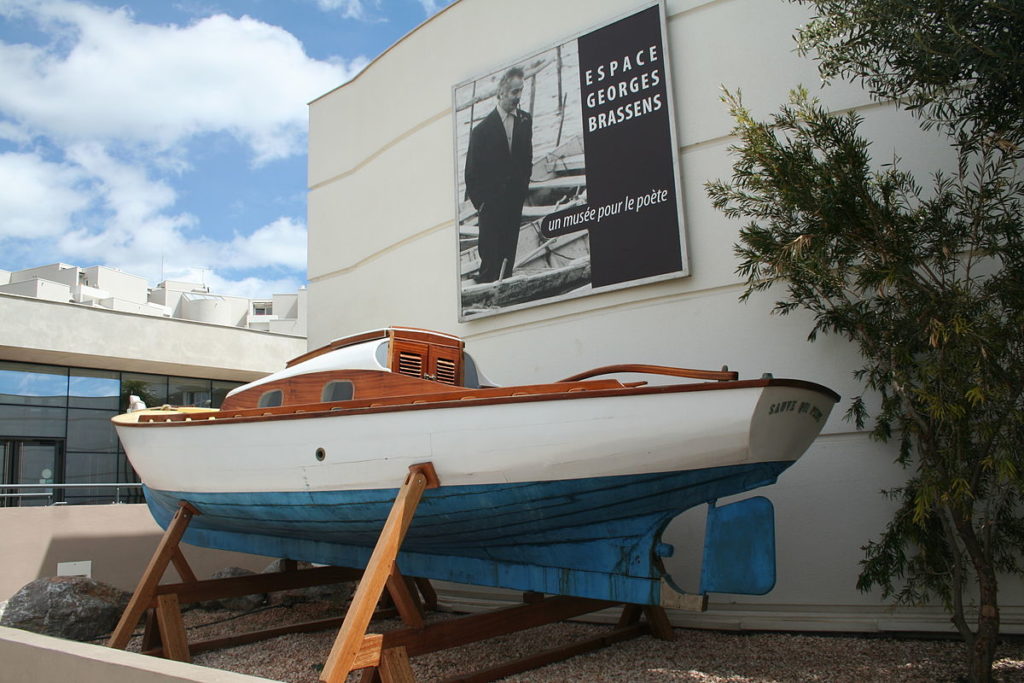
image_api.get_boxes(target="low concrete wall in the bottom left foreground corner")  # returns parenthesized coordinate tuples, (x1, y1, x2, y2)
(0, 627, 269, 683)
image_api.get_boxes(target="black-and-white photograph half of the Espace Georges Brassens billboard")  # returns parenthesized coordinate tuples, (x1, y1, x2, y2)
(454, 41, 590, 319)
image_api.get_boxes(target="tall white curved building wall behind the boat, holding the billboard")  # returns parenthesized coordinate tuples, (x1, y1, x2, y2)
(308, 0, 1024, 631)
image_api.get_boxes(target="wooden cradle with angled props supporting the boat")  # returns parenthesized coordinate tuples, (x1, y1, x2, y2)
(108, 463, 674, 683)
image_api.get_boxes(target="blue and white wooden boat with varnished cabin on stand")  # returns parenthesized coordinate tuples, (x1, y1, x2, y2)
(113, 327, 839, 605)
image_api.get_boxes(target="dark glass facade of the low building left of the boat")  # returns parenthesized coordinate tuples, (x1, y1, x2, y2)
(0, 360, 242, 506)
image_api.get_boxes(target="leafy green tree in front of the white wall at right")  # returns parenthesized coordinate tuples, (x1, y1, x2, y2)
(708, 0, 1024, 681)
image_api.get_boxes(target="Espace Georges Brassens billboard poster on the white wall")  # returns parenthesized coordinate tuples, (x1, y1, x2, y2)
(453, 2, 689, 321)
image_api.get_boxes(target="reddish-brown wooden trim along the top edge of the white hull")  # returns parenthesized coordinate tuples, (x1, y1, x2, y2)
(118, 379, 840, 427)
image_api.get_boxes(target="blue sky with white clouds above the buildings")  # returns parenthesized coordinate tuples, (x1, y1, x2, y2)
(0, 0, 451, 298)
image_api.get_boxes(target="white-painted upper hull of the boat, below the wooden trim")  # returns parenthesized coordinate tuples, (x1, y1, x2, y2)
(118, 385, 834, 493)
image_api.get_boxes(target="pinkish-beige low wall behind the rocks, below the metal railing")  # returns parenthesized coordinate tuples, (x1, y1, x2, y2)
(0, 505, 271, 601)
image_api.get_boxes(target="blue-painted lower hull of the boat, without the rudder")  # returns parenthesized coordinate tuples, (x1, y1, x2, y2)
(145, 462, 792, 604)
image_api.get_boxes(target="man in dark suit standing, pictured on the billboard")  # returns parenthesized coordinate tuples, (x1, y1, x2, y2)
(466, 67, 534, 283)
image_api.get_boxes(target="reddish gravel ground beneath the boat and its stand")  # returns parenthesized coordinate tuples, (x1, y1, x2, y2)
(117, 603, 1024, 683)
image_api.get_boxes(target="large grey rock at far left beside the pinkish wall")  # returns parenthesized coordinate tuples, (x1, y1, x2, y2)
(0, 577, 131, 641)
